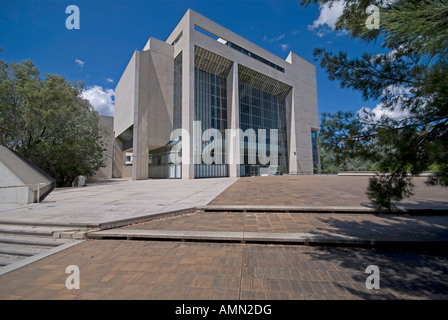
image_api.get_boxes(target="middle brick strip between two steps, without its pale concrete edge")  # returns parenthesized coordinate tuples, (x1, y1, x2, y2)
(121, 212, 448, 241)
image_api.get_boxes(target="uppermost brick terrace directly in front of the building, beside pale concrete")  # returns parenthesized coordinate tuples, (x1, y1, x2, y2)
(209, 175, 448, 209)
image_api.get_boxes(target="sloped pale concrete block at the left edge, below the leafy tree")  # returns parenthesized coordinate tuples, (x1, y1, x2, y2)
(0, 146, 56, 209)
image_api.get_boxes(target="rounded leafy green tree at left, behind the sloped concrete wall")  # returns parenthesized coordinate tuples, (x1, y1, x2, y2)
(0, 60, 105, 186)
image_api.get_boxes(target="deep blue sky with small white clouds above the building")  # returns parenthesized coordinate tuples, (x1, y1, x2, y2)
(0, 0, 381, 119)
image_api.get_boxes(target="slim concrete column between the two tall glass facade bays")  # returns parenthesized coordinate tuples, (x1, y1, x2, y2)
(226, 62, 241, 178)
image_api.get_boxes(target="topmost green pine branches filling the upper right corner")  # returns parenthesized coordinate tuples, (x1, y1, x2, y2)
(301, 0, 448, 58)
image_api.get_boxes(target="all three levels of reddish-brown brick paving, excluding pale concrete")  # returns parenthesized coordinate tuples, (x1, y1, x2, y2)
(0, 176, 448, 300)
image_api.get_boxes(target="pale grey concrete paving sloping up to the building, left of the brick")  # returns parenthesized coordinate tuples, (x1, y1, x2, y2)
(0, 178, 236, 228)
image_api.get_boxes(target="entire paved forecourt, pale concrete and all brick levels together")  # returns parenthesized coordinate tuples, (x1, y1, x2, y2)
(0, 176, 448, 300)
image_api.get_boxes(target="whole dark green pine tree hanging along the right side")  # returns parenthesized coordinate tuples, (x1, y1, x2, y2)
(302, 0, 448, 209)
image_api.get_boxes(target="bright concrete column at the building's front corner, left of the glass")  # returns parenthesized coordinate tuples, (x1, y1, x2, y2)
(182, 42, 194, 179)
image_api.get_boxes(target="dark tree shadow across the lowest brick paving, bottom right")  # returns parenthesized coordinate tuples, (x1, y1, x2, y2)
(300, 240, 448, 300)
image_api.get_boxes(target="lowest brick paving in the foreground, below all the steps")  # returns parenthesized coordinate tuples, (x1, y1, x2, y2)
(0, 240, 448, 300)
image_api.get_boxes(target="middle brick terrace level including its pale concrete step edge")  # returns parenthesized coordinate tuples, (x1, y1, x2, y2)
(93, 212, 448, 247)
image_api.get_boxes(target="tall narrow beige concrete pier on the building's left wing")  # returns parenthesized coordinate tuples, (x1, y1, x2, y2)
(132, 52, 149, 180)
